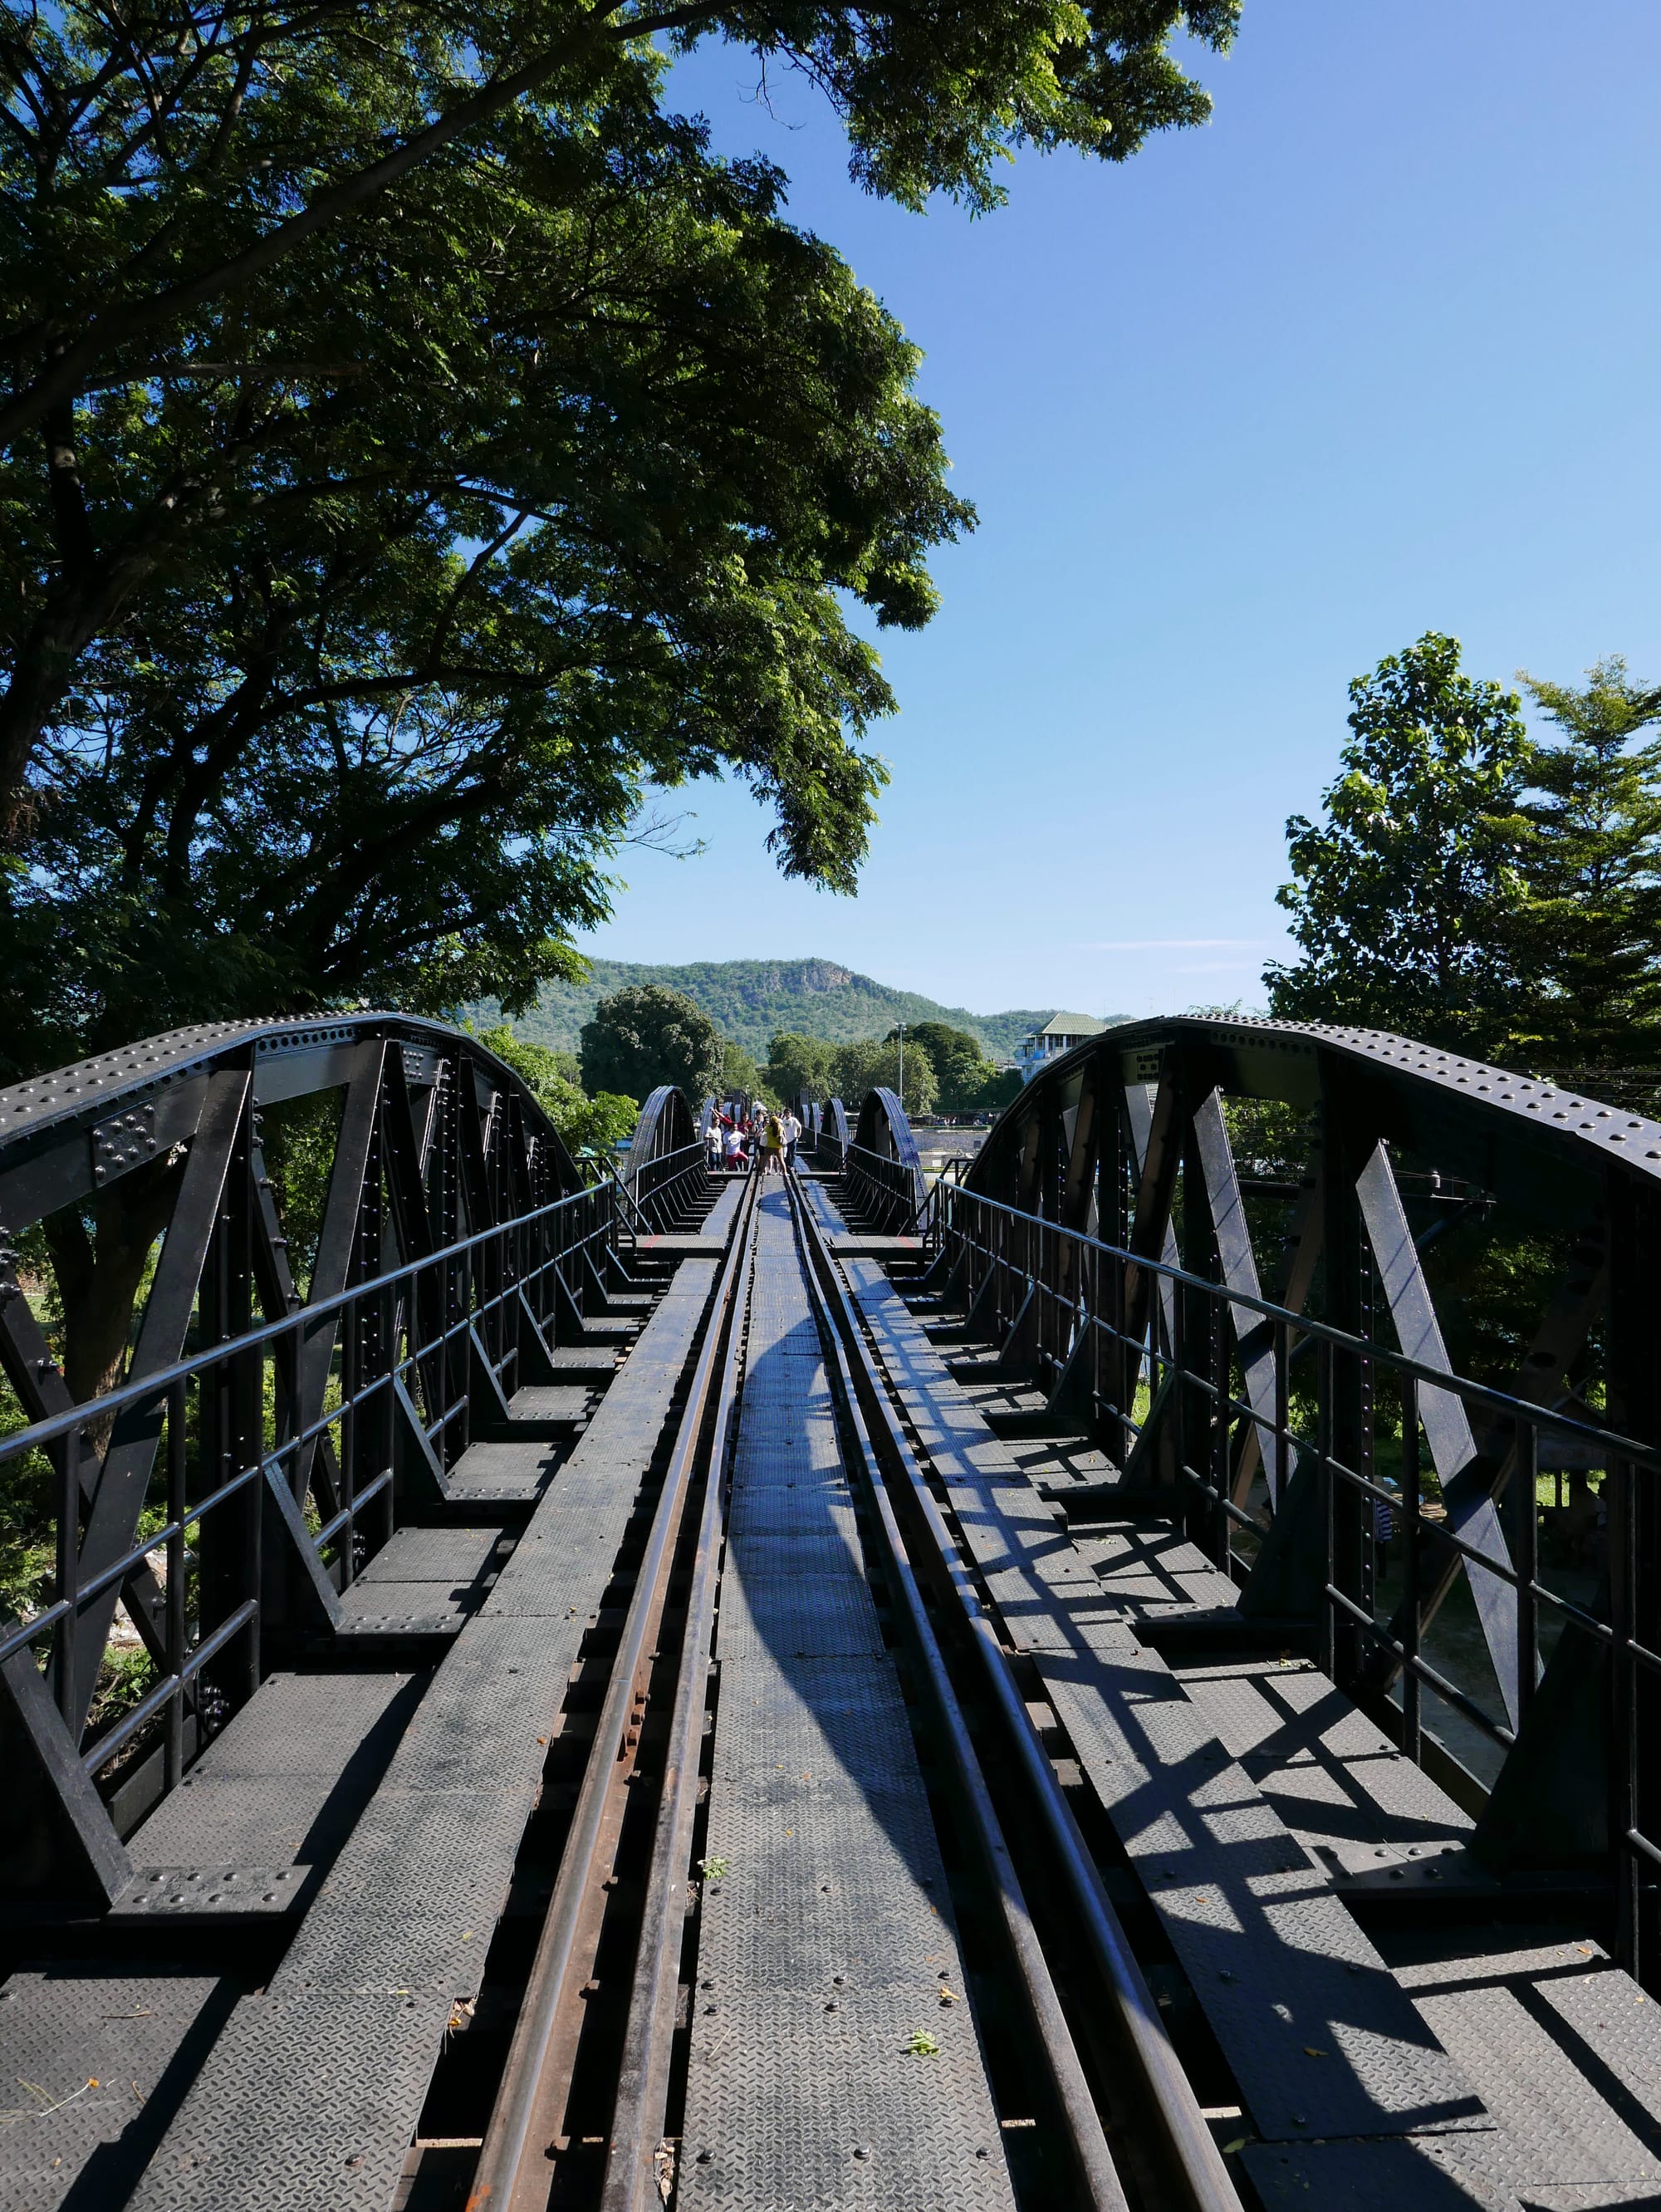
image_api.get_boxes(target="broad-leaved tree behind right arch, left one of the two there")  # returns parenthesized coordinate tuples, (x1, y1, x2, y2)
(1263, 630, 1528, 1051)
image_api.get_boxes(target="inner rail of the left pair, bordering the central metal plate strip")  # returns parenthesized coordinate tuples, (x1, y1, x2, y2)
(600, 1177, 758, 2212)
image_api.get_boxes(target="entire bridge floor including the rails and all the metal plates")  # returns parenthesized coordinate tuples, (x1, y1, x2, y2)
(12, 1123, 1650, 2212)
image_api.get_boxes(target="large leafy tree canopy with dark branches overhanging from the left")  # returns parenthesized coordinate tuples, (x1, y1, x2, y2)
(0, 0, 1234, 1075)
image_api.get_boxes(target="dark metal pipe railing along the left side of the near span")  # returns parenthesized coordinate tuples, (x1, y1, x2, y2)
(0, 1188, 615, 1788)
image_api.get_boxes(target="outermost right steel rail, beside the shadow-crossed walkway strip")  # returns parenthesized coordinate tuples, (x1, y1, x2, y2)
(796, 1194, 1241, 2212)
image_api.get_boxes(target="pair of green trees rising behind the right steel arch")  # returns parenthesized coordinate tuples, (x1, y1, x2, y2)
(1265, 633, 1661, 1088)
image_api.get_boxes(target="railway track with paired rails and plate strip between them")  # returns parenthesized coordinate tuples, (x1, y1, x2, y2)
(400, 1179, 1238, 2212)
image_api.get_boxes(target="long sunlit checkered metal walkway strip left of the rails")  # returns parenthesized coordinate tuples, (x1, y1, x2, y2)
(133, 1261, 714, 2212)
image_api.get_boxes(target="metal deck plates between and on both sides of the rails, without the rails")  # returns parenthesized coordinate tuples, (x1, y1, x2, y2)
(0, 1181, 1661, 2212)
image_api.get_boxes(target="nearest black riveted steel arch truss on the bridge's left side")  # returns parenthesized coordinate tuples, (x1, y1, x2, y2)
(0, 1015, 641, 1901)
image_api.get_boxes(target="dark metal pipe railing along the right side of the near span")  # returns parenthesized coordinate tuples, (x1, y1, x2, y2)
(931, 1184, 1661, 1787)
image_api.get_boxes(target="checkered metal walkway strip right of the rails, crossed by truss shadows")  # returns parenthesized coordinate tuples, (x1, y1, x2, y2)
(847, 1263, 1491, 2141)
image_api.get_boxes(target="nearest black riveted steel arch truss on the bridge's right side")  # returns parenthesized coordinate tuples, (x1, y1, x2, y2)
(924, 1018, 1661, 1982)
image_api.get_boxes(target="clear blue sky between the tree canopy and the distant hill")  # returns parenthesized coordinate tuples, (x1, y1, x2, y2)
(586, 0, 1661, 1015)
